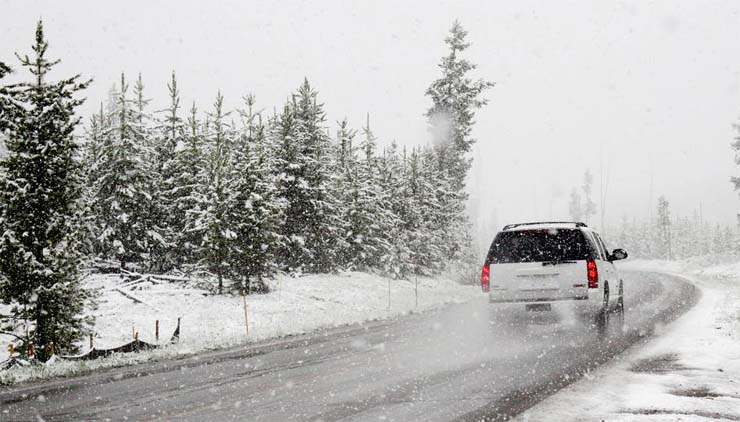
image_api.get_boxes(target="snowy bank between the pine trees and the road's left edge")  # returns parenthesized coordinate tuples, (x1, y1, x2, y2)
(0, 272, 481, 384)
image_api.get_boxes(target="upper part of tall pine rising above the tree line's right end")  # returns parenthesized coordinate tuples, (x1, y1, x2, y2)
(426, 21, 494, 192)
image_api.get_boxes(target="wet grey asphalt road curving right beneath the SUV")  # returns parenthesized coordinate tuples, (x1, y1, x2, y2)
(0, 272, 699, 421)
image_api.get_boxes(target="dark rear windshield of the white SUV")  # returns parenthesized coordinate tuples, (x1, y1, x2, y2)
(487, 229, 591, 264)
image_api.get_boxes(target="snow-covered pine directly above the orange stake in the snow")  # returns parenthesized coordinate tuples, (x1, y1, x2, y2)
(229, 95, 282, 293)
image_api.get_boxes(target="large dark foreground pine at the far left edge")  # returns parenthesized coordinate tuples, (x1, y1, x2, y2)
(0, 21, 89, 360)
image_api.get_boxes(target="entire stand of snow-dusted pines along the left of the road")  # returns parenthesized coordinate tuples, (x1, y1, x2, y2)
(0, 22, 493, 359)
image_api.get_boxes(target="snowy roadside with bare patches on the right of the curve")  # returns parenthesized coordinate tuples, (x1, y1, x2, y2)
(516, 259, 740, 422)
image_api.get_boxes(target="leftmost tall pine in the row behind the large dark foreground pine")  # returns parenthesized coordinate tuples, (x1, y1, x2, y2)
(95, 74, 152, 268)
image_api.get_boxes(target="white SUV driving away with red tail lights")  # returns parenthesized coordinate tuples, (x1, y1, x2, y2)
(481, 222, 627, 321)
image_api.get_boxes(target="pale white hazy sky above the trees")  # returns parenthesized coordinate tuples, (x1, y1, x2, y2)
(0, 0, 740, 232)
